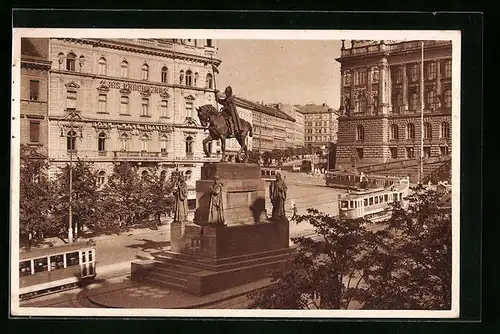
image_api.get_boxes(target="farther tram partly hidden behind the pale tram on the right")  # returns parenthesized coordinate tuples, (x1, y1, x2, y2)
(325, 171, 401, 189)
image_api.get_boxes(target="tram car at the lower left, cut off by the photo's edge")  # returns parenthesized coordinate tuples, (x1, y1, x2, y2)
(19, 241, 96, 300)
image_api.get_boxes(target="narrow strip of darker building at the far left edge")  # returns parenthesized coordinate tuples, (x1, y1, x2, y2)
(20, 38, 50, 156)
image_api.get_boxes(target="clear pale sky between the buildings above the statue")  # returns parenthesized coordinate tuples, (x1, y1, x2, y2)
(216, 39, 341, 108)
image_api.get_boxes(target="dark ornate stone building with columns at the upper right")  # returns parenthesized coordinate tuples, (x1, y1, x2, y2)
(336, 41, 452, 168)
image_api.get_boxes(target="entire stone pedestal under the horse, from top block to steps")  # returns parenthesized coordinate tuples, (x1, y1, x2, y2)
(132, 163, 294, 296)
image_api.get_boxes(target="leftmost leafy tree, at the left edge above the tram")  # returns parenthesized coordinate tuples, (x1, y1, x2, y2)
(19, 145, 57, 247)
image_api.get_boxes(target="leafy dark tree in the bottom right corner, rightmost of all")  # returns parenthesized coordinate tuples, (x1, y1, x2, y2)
(362, 187, 452, 310)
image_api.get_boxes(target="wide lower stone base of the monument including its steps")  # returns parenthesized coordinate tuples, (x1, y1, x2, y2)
(132, 220, 294, 296)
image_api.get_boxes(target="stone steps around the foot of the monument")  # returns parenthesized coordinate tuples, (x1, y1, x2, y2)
(132, 248, 295, 292)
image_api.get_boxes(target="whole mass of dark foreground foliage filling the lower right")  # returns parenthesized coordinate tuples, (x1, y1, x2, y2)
(250, 188, 451, 310)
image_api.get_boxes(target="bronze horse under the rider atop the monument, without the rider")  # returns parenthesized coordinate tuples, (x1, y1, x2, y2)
(196, 104, 253, 162)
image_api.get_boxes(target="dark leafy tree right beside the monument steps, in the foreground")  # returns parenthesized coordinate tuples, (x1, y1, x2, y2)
(250, 209, 382, 309)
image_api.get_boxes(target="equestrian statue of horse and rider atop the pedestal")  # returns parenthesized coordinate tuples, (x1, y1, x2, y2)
(196, 86, 253, 162)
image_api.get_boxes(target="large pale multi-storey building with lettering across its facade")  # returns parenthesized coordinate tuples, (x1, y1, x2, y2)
(48, 38, 221, 198)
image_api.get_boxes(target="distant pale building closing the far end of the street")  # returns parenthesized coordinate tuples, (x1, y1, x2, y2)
(299, 103, 338, 148)
